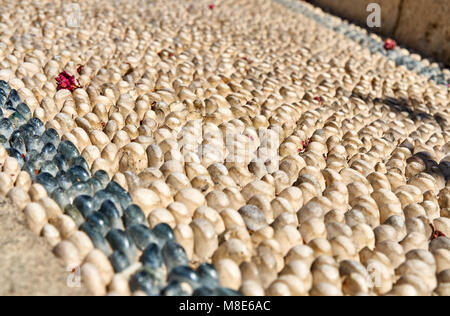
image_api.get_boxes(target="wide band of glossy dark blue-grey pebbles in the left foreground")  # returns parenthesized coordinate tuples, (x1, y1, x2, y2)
(0, 80, 240, 296)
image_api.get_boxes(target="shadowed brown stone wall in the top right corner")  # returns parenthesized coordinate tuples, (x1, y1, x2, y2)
(312, 0, 450, 65)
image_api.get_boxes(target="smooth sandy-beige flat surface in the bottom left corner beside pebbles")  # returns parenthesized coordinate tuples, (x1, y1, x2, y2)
(0, 201, 88, 296)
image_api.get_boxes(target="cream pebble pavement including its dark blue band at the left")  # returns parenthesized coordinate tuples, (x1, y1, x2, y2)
(0, 0, 450, 296)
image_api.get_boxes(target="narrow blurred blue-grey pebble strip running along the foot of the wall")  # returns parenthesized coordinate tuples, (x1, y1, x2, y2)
(273, 0, 450, 87)
